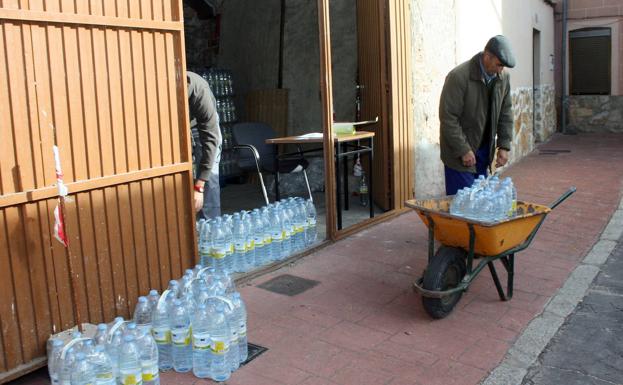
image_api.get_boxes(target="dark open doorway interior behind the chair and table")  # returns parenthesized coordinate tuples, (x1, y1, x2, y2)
(184, 0, 393, 239)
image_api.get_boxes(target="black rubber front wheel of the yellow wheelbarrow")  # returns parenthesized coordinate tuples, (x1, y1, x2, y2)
(422, 246, 466, 319)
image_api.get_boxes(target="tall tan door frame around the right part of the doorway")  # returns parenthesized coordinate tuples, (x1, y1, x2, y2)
(317, 0, 415, 240)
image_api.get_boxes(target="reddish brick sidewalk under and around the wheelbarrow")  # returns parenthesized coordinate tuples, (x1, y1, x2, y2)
(12, 134, 623, 385)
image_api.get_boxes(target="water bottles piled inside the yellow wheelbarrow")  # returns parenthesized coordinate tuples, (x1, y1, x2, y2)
(450, 174, 517, 222)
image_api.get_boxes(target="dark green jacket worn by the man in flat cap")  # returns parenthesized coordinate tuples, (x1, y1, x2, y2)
(439, 53, 513, 173)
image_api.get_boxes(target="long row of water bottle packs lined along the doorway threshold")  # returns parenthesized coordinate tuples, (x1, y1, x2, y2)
(197, 197, 318, 274)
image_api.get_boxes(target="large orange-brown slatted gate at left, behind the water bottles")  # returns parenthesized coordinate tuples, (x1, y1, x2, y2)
(0, 0, 196, 383)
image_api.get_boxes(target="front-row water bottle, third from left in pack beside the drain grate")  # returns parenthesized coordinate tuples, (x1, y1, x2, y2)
(192, 302, 212, 378)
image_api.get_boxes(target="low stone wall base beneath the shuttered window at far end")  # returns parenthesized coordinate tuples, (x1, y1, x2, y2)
(567, 95, 623, 133)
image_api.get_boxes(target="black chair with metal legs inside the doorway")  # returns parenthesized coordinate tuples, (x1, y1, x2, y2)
(231, 122, 312, 204)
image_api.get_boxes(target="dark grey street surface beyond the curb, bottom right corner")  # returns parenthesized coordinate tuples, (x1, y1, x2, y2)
(523, 232, 623, 385)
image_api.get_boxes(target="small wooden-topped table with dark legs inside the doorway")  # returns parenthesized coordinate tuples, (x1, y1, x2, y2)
(266, 131, 374, 230)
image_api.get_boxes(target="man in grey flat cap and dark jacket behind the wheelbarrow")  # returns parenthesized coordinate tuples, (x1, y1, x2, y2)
(439, 35, 515, 195)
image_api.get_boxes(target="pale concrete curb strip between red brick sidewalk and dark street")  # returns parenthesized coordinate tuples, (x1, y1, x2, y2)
(480, 198, 623, 385)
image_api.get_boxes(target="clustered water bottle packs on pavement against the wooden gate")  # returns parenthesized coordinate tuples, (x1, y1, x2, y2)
(48, 265, 248, 385)
